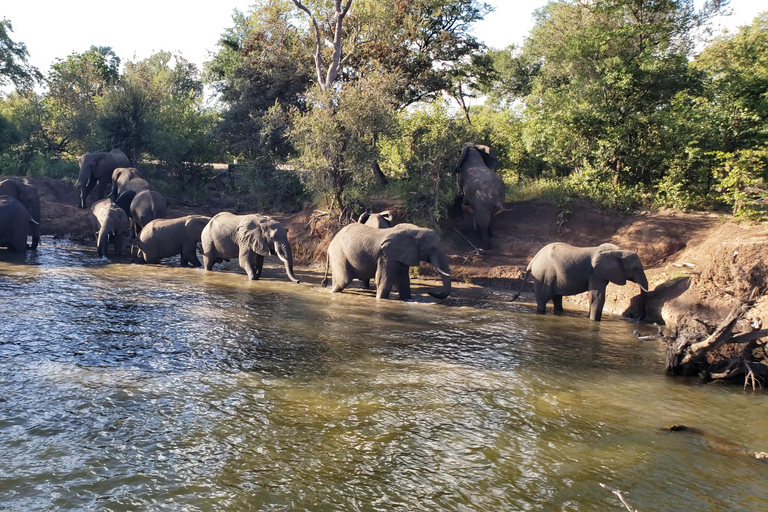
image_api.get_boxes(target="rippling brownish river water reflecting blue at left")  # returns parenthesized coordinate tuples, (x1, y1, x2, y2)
(0, 238, 768, 511)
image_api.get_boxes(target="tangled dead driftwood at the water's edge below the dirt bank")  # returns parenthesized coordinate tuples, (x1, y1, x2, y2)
(660, 288, 768, 389)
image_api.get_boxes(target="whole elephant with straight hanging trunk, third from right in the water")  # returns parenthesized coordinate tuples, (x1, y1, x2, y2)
(202, 212, 300, 283)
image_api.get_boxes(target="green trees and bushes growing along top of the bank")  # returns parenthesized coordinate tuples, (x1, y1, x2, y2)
(0, 0, 768, 220)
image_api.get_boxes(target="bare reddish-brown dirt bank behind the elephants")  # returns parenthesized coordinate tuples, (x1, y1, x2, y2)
(12, 178, 768, 327)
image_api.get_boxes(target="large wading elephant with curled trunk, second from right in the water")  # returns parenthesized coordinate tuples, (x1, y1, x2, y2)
(322, 223, 451, 300)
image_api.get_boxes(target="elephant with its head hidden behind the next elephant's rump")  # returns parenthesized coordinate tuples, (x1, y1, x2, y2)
(132, 215, 211, 267)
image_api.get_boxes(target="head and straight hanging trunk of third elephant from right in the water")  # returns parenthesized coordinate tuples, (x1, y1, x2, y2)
(236, 215, 300, 283)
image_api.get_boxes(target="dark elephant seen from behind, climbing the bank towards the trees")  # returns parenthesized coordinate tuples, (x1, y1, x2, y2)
(456, 144, 506, 249)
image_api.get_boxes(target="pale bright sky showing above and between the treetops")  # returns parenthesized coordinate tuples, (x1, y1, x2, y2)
(0, 0, 768, 81)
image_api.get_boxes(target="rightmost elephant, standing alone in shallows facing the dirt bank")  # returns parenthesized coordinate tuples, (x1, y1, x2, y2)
(512, 242, 648, 322)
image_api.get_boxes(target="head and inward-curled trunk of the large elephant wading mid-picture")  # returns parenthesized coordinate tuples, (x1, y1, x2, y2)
(381, 224, 451, 299)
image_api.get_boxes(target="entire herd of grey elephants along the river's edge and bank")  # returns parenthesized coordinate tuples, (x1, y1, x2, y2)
(0, 144, 648, 321)
